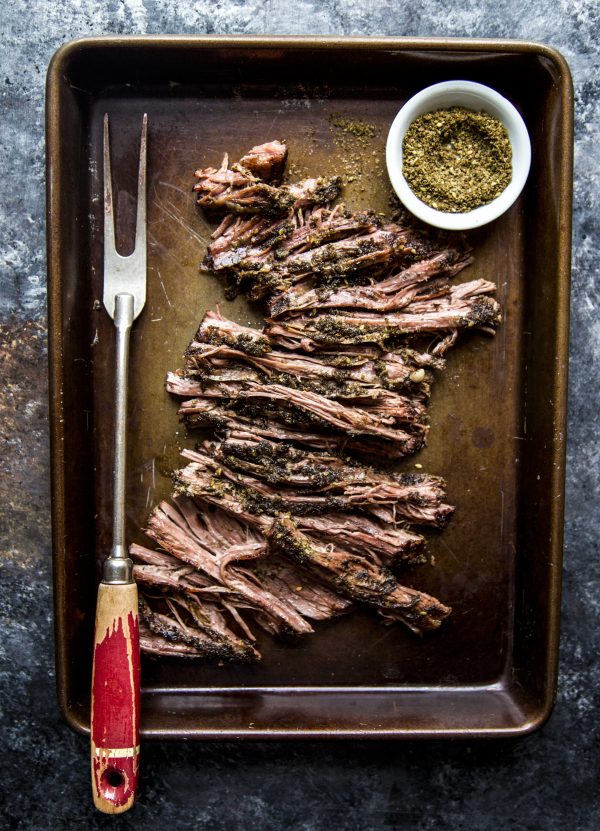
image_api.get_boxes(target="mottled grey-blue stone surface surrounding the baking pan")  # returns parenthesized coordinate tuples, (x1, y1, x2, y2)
(0, 0, 600, 831)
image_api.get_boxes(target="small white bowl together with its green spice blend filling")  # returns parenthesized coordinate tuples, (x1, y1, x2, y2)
(385, 80, 531, 231)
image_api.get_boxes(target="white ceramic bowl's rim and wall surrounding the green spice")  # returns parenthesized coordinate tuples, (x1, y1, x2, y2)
(386, 81, 531, 231)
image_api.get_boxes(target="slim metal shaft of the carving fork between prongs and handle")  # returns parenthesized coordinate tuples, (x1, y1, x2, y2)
(102, 292, 133, 584)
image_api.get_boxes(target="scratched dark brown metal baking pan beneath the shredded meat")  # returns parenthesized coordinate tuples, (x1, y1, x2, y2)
(47, 37, 572, 738)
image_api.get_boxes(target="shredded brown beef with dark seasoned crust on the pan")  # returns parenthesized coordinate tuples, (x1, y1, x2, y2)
(131, 141, 501, 661)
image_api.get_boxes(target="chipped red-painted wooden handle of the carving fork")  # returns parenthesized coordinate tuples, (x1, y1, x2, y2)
(91, 583, 140, 814)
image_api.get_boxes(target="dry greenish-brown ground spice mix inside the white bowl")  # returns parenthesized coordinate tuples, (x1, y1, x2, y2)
(402, 107, 512, 213)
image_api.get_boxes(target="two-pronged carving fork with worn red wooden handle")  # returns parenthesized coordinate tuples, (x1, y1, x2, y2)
(91, 115, 147, 814)
